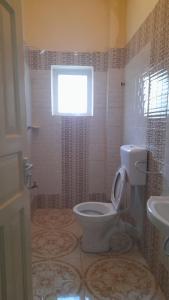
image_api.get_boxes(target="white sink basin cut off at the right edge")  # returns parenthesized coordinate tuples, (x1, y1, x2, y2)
(147, 196, 169, 236)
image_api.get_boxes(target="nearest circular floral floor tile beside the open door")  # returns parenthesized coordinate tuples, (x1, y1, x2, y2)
(32, 261, 81, 299)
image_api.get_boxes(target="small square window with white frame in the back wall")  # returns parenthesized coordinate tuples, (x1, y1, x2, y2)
(51, 66, 93, 116)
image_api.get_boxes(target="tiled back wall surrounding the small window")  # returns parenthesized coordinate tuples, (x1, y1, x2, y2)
(29, 49, 124, 207)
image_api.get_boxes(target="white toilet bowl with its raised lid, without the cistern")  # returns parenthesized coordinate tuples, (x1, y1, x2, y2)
(73, 167, 126, 253)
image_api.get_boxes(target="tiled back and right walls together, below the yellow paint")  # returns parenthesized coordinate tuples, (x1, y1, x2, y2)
(25, 0, 169, 299)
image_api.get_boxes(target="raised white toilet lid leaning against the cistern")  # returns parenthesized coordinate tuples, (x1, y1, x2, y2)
(111, 167, 126, 210)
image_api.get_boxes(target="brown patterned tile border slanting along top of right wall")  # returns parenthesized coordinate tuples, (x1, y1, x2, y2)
(125, 0, 169, 66)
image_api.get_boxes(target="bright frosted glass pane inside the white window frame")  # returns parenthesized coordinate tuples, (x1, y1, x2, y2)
(58, 75, 87, 114)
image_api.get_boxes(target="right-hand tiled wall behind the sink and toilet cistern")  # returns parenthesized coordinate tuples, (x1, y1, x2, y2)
(123, 0, 169, 299)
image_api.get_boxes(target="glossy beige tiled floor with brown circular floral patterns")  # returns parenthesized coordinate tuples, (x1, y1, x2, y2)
(32, 209, 164, 300)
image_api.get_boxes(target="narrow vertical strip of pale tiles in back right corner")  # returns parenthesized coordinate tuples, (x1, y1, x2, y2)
(105, 64, 124, 200)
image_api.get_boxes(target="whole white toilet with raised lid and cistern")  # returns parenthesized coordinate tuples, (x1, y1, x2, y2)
(73, 145, 147, 252)
